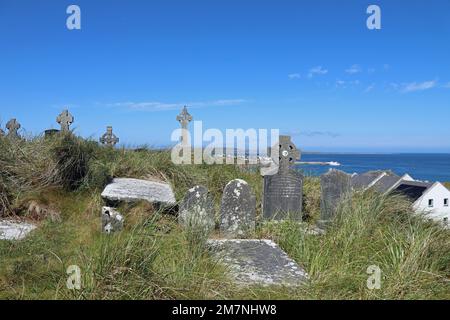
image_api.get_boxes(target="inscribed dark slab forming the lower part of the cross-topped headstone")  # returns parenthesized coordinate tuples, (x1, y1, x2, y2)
(263, 171, 303, 220)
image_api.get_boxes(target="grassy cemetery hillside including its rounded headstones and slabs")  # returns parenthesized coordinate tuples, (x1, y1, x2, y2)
(0, 131, 450, 299)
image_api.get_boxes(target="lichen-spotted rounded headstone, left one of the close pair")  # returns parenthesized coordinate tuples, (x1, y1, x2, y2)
(178, 186, 215, 233)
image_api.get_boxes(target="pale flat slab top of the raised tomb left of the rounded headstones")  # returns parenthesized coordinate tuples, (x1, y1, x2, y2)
(102, 178, 176, 205)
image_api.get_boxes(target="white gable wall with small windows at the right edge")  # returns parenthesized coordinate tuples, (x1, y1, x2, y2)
(414, 182, 450, 226)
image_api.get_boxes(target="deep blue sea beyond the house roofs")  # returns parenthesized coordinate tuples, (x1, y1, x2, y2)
(296, 153, 450, 182)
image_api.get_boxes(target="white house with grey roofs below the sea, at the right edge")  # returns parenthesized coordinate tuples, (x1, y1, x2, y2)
(351, 171, 450, 225)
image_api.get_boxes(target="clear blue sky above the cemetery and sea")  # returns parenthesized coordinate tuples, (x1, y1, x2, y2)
(0, 0, 450, 152)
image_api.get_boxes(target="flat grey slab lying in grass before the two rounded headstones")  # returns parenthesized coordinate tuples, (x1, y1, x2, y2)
(208, 239, 308, 286)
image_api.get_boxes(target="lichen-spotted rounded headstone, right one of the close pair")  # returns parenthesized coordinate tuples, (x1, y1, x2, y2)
(220, 179, 256, 238)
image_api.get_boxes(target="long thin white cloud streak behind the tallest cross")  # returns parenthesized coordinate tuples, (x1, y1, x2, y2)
(107, 99, 246, 111)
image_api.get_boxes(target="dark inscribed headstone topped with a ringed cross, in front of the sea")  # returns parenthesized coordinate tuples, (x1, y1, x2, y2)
(263, 136, 303, 220)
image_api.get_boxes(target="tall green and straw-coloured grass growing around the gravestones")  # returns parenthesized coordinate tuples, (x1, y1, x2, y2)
(0, 135, 450, 299)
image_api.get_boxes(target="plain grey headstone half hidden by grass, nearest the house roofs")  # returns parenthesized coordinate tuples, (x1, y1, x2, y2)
(319, 169, 352, 227)
